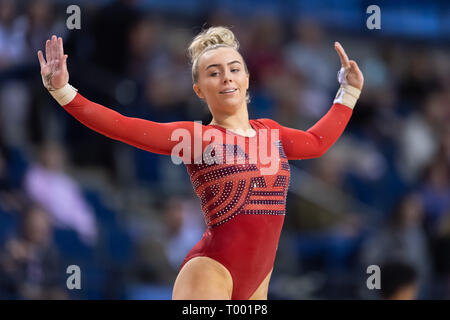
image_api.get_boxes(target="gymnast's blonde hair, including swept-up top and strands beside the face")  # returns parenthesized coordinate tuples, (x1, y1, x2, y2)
(188, 26, 250, 103)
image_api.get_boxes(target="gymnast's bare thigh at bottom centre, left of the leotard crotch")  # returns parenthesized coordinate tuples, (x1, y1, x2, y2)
(172, 256, 233, 300)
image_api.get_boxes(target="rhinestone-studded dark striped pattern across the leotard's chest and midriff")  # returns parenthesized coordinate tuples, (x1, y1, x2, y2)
(186, 135, 290, 228)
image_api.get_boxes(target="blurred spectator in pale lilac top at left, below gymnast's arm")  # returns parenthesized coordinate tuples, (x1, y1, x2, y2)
(25, 142, 97, 245)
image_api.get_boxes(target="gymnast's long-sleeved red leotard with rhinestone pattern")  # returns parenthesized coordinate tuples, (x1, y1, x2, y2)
(63, 93, 352, 299)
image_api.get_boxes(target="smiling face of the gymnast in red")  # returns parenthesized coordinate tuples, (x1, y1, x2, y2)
(193, 47, 249, 115)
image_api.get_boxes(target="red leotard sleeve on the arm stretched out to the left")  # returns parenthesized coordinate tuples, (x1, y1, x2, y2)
(63, 93, 199, 155)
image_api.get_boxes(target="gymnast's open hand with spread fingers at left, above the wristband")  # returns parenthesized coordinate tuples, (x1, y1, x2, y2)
(38, 35, 69, 91)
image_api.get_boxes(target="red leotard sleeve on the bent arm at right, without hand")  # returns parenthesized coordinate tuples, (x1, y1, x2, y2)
(260, 103, 353, 160)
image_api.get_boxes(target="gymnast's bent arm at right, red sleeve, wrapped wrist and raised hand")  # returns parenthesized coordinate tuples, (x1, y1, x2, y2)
(271, 42, 364, 160)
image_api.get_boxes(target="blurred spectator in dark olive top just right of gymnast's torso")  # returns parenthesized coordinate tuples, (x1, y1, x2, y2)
(287, 148, 364, 279)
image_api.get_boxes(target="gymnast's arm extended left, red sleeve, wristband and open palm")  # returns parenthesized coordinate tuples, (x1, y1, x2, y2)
(38, 36, 194, 155)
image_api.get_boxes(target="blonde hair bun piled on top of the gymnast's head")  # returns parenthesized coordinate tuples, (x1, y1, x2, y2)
(188, 27, 239, 63)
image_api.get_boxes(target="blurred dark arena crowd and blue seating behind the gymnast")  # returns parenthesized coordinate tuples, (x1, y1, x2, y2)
(0, 0, 450, 299)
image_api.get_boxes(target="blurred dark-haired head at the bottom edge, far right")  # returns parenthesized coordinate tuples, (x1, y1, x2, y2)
(380, 261, 418, 300)
